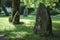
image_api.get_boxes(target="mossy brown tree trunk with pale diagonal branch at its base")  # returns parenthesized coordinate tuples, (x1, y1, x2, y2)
(9, 0, 20, 24)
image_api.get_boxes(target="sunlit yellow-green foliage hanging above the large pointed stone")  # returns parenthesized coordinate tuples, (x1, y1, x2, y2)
(21, 0, 58, 8)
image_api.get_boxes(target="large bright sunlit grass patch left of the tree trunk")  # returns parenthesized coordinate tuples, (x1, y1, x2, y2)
(0, 18, 16, 31)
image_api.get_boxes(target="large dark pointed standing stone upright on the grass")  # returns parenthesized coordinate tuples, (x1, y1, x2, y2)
(34, 3, 52, 35)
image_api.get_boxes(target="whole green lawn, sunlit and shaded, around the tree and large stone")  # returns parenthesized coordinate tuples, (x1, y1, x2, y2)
(0, 15, 60, 40)
